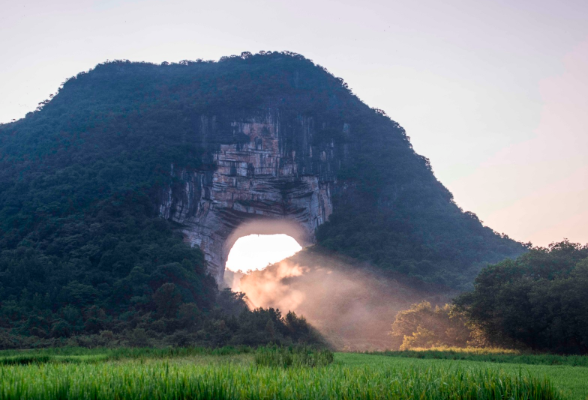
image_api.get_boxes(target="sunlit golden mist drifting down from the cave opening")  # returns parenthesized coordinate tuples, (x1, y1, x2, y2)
(230, 249, 451, 351)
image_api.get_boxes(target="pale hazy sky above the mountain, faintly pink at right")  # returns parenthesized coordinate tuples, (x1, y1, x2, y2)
(0, 0, 588, 245)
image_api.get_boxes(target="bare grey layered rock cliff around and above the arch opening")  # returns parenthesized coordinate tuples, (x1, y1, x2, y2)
(159, 111, 338, 282)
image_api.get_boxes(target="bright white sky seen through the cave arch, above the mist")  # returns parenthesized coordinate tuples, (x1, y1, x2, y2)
(227, 235, 302, 272)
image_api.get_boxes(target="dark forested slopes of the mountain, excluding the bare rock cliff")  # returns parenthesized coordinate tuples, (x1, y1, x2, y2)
(0, 52, 525, 344)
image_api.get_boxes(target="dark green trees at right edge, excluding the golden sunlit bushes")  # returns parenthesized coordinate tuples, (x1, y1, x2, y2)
(456, 240, 588, 354)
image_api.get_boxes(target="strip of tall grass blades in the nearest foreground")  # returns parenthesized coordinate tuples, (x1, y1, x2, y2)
(0, 360, 563, 400)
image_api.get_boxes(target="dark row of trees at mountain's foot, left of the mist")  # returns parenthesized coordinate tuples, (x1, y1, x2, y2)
(0, 283, 326, 349)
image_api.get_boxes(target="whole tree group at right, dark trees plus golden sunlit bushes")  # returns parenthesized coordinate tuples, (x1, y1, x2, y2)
(391, 240, 588, 354)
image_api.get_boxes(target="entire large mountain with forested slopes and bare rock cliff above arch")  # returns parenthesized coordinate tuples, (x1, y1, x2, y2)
(0, 52, 525, 344)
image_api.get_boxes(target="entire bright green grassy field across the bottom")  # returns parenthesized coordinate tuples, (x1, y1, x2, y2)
(0, 348, 588, 400)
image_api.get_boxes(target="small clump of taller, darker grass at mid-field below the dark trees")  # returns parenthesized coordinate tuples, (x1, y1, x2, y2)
(255, 346, 334, 368)
